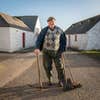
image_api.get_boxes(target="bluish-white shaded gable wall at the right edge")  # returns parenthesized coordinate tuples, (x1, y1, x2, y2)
(87, 21, 100, 50)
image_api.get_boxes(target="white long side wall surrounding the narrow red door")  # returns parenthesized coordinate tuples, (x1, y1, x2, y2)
(10, 28, 34, 52)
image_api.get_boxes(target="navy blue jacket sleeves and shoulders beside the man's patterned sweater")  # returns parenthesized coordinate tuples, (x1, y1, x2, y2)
(36, 26, 67, 53)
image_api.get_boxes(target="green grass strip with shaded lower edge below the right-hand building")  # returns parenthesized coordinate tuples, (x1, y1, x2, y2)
(80, 50, 100, 61)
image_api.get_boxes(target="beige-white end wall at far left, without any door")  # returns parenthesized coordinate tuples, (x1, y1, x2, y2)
(0, 27, 10, 51)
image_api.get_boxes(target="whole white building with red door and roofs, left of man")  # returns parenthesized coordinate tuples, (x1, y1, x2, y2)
(0, 13, 41, 52)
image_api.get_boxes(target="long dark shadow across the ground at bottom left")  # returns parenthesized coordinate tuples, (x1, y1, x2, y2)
(0, 84, 63, 100)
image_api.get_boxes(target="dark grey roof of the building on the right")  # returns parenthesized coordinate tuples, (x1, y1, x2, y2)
(65, 15, 100, 34)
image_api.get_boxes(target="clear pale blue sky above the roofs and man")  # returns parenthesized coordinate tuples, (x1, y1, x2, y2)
(0, 0, 100, 30)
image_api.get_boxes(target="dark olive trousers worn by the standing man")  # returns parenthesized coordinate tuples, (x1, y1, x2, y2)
(43, 50, 66, 82)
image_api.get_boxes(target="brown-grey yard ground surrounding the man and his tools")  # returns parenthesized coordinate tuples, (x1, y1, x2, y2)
(0, 52, 100, 100)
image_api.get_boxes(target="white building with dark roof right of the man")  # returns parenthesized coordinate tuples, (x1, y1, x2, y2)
(65, 15, 100, 50)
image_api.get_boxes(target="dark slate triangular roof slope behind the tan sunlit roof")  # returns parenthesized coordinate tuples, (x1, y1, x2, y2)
(16, 16, 38, 32)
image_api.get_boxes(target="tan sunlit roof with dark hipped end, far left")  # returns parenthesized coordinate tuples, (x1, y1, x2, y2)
(0, 13, 32, 31)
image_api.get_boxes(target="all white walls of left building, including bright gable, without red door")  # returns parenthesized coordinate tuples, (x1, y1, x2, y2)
(0, 18, 41, 52)
